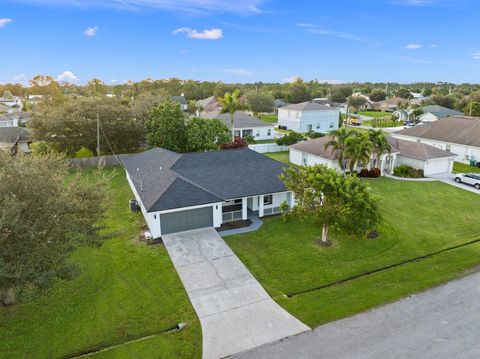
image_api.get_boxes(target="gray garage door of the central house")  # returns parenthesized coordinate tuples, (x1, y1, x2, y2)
(160, 207, 213, 234)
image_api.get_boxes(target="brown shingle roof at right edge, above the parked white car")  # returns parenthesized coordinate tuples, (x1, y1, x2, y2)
(395, 116, 480, 147)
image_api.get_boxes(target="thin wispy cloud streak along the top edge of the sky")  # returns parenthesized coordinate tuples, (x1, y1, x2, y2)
(12, 0, 267, 15)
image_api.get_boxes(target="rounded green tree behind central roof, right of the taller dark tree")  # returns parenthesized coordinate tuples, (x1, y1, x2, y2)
(186, 118, 230, 152)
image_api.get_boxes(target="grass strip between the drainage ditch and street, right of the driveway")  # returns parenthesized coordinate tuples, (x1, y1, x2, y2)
(275, 243, 480, 327)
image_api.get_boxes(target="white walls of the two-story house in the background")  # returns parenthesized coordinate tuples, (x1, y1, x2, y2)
(278, 108, 340, 133)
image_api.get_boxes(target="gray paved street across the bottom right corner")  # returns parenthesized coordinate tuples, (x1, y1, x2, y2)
(233, 272, 480, 359)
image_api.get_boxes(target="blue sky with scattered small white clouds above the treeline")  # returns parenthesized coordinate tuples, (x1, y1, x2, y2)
(0, 0, 480, 84)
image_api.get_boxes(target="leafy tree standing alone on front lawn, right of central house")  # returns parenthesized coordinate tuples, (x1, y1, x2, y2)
(282, 165, 380, 246)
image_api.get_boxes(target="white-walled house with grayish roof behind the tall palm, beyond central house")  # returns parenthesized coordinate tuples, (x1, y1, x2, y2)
(201, 110, 275, 140)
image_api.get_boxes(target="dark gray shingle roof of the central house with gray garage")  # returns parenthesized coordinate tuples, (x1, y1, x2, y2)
(124, 148, 286, 212)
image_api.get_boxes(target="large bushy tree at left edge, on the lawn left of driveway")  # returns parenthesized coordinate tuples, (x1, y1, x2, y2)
(0, 151, 109, 304)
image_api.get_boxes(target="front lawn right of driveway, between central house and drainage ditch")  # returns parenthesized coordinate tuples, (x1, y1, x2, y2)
(226, 178, 480, 296)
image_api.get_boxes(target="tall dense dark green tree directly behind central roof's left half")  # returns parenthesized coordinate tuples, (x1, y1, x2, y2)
(146, 101, 186, 152)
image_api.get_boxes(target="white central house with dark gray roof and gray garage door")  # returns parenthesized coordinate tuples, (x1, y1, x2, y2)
(124, 148, 293, 238)
